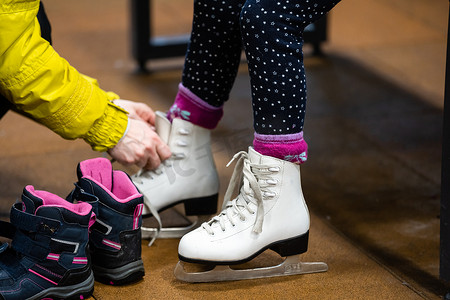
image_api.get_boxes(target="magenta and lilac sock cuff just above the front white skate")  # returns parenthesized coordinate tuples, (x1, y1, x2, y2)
(253, 131, 308, 164)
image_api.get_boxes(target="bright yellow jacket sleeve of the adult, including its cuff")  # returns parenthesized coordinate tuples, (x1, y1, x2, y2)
(0, 0, 128, 151)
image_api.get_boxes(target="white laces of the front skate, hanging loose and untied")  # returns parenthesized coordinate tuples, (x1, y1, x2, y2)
(202, 151, 280, 235)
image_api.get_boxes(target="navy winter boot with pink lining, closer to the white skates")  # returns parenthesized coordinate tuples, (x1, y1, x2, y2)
(67, 158, 145, 285)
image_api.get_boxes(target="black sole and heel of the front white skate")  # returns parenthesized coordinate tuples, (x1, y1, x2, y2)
(178, 230, 309, 265)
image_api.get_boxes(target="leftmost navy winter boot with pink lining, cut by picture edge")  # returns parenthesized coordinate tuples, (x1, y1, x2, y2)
(0, 185, 94, 300)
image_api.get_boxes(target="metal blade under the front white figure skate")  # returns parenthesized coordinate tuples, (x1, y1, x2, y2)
(174, 255, 328, 283)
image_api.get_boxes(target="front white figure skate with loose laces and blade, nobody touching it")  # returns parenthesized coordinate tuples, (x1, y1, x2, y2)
(174, 147, 328, 282)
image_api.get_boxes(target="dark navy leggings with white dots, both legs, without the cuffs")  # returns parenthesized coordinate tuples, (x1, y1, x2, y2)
(182, 0, 340, 135)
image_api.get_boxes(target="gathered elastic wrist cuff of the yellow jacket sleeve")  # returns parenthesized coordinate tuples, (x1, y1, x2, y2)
(83, 101, 128, 152)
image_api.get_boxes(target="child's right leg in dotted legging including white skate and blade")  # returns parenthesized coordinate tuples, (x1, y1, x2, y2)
(175, 0, 337, 282)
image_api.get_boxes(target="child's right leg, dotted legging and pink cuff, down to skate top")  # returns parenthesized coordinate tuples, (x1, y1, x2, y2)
(241, 0, 339, 163)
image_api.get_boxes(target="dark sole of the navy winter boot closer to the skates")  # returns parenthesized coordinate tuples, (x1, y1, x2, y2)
(92, 260, 145, 285)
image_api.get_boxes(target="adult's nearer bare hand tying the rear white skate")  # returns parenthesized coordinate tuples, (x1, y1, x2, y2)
(108, 118, 172, 170)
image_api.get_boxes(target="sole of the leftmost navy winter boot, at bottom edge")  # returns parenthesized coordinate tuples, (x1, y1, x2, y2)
(27, 271, 94, 300)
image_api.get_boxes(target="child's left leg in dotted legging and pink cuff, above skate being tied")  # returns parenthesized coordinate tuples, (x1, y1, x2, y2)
(169, 0, 245, 129)
